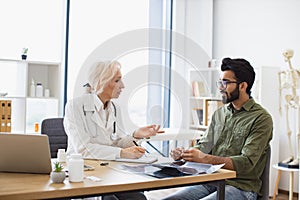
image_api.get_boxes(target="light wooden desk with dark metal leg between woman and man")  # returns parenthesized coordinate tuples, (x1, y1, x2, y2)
(0, 160, 236, 200)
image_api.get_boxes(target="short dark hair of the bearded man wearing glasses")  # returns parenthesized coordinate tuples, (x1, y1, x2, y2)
(221, 58, 255, 96)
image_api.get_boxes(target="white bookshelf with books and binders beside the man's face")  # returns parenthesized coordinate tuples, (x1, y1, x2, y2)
(189, 68, 223, 130)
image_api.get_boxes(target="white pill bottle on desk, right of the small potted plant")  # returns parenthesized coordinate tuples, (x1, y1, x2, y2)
(68, 154, 84, 182)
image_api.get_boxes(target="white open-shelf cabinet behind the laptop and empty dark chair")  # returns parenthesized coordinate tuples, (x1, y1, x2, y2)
(0, 59, 63, 133)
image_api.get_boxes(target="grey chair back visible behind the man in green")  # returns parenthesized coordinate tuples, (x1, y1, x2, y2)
(257, 147, 271, 200)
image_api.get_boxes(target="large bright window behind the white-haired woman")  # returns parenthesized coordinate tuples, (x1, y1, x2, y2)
(67, 0, 172, 133)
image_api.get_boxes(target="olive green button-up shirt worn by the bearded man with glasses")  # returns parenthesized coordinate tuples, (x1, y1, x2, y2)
(196, 98, 273, 194)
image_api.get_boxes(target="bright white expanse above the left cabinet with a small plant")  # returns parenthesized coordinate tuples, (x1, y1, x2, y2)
(0, 0, 65, 62)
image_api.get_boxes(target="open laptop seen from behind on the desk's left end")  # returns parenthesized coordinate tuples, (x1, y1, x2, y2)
(0, 133, 52, 174)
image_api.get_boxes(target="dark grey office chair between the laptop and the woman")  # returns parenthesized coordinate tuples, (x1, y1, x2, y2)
(42, 118, 68, 158)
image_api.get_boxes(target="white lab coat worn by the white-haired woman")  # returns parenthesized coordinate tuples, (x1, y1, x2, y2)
(64, 94, 133, 160)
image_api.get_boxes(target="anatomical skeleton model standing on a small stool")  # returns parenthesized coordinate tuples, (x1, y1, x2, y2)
(278, 49, 300, 168)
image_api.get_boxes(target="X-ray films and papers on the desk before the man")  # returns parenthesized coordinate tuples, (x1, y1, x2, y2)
(122, 161, 224, 178)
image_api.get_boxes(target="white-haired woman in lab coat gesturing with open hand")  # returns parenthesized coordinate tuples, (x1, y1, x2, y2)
(64, 61, 163, 199)
